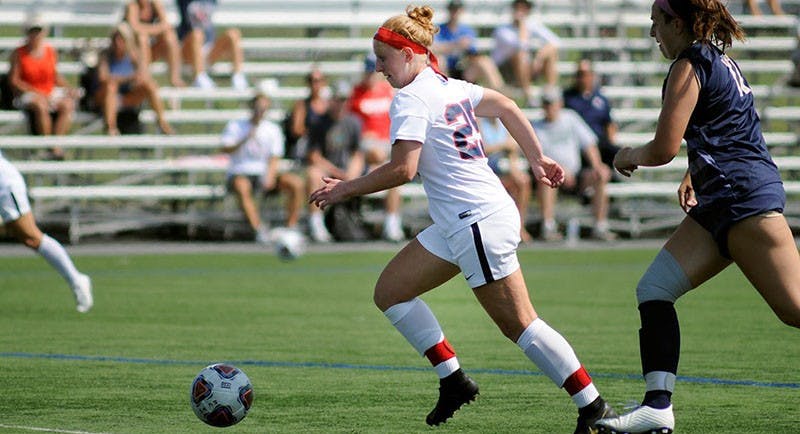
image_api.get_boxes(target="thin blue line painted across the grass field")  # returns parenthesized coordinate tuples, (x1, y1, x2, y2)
(0, 352, 800, 389)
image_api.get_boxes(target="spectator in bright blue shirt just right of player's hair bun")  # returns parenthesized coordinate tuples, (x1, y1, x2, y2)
(433, 0, 505, 90)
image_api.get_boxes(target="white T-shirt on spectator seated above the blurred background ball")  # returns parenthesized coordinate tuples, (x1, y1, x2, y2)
(222, 119, 284, 176)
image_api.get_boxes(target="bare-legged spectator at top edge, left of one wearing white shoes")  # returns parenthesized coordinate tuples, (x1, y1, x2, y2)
(125, 0, 186, 87)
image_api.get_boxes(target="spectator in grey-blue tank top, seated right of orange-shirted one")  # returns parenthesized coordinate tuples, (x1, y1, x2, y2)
(94, 22, 174, 136)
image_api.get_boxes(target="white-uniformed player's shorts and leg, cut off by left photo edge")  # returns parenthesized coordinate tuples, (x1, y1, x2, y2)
(0, 153, 93, 313)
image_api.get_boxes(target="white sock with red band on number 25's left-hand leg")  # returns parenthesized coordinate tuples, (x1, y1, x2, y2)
(383, 298, 459, 378)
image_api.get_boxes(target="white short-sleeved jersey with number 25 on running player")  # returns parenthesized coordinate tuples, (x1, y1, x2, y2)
(390, 68, 514, 236)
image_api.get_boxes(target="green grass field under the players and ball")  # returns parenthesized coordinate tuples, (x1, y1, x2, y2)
(0, 246, 800, 434)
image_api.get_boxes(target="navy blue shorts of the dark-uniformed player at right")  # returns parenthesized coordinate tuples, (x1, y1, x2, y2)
(689, 182, 786, 259)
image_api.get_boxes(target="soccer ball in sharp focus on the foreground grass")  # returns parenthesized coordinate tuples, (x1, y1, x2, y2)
(189, 363, 253, 427)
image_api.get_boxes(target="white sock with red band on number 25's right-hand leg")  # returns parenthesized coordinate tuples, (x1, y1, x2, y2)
(517, 318, 600, 408)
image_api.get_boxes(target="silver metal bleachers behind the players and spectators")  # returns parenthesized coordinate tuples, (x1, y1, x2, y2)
(0, 0, 800, 242)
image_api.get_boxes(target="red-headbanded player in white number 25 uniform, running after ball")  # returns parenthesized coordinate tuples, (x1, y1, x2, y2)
(310, 6, 616, 434)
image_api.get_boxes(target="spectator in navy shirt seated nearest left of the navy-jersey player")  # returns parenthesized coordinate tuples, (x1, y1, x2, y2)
(564, 59, 619, 171)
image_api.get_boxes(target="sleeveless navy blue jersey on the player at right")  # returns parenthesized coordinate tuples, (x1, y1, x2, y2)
(662, 42, 781, 208)
